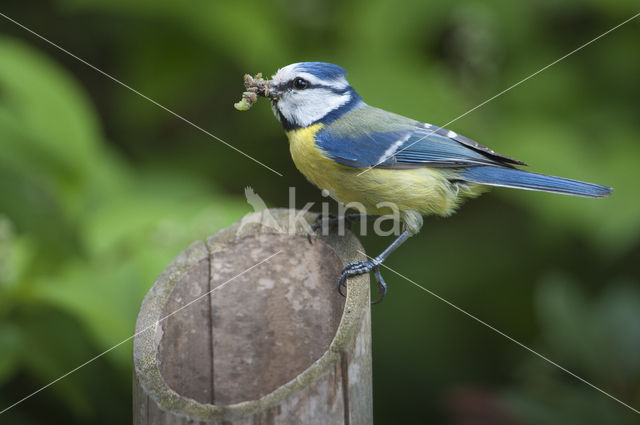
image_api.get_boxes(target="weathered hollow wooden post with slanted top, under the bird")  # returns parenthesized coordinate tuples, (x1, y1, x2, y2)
(133, 210, 373, 425)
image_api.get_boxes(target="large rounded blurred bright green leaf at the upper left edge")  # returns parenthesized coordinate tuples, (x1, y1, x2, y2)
(0, 38, 105, 212)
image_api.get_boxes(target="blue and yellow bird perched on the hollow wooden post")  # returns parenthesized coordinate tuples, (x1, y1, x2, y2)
(255, 62, 613, 302)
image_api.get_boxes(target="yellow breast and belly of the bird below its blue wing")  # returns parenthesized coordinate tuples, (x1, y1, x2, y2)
(287, 123, 482, 215)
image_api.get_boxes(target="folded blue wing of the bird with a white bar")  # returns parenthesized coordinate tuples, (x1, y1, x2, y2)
(316, 119, 525, 168)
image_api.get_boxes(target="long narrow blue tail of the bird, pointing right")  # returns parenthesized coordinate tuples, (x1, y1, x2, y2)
(462, 166, 613, 198)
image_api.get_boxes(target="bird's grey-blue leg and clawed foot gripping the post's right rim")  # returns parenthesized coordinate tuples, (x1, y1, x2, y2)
(338, 211, 422, 304)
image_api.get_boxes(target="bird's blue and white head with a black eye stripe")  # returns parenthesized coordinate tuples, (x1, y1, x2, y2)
(269, 62, 362, 130)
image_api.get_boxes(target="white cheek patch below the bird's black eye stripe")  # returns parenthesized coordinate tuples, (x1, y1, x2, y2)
(278, 89, 351, 127)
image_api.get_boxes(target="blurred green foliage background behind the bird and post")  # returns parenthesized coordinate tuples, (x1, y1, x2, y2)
(0, 0, 640, 424)
